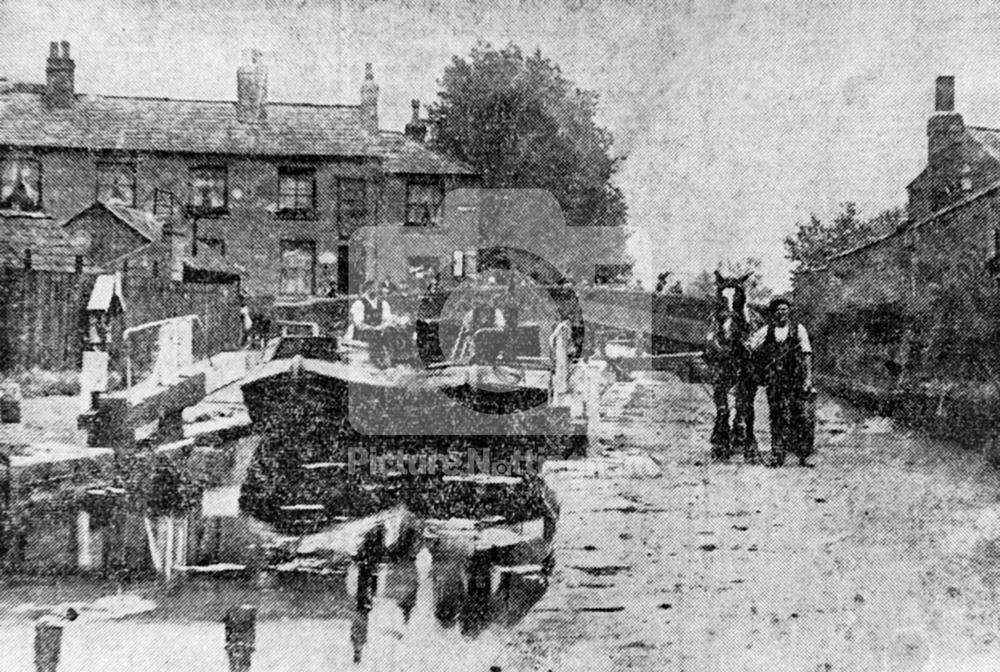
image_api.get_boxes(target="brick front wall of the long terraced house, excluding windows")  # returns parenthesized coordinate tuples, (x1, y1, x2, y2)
(4, 149, 480, 297)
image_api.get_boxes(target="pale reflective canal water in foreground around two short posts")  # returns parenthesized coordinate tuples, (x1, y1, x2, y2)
(0, 439, 549, 672)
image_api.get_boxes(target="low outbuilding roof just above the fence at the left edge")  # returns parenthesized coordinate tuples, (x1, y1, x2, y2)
(0, 210, 97, 272)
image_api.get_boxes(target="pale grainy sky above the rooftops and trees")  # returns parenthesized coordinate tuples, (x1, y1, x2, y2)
(0, 0, 1000, 291)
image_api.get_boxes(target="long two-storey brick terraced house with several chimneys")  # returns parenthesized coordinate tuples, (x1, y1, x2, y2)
(0, 42, 478, 297)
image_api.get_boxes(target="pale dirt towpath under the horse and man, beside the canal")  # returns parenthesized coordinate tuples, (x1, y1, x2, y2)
(499, 381, 1000, 672)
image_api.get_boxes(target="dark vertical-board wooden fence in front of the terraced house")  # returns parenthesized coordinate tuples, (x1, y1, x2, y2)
(0, 268, 241, 371)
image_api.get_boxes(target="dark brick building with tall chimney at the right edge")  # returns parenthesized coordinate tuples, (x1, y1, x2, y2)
(794, 77, 1000, 385)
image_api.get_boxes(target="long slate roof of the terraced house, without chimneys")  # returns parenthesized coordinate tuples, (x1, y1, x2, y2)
(0, 87, 473, 174)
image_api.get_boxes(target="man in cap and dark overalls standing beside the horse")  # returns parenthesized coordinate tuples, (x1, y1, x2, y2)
(749, 297, 815, 467)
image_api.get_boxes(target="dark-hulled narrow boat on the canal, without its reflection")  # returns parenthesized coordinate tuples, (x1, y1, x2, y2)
(242, 328, 571, 458)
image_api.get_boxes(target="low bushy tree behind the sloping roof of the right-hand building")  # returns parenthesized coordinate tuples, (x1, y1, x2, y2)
(785, 202, 903, 268)
